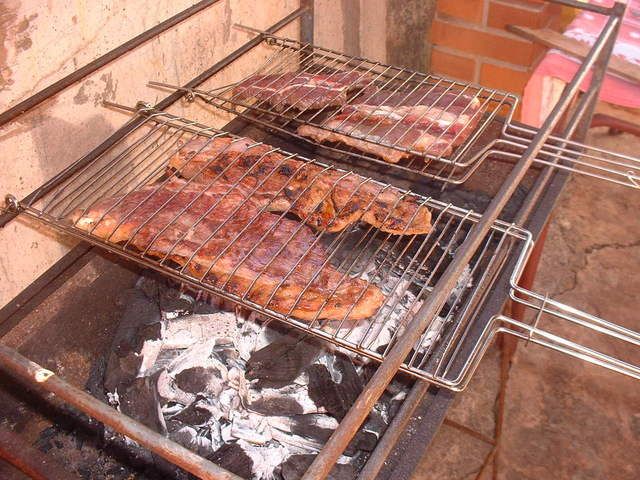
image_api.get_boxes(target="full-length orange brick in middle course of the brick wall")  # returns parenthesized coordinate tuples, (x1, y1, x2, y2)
(431, 19, 543, 67)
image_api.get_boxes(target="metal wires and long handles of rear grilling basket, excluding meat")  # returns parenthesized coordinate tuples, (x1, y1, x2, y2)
(149, 34, 640, 189)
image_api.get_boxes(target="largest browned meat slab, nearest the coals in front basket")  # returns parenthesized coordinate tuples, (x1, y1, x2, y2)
(71, 178, 385, 324)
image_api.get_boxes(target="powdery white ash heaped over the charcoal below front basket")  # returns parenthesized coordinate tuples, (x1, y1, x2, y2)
(121, 312, 349, 480)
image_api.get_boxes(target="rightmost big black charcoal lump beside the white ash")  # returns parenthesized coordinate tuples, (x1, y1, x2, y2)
(307, 356, 363, 420)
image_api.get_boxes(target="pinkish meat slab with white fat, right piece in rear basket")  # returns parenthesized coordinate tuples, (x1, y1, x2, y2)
(298, 88, 480, 163)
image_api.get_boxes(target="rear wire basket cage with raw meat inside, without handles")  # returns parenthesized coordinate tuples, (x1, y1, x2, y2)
(149, 35, 518, 183)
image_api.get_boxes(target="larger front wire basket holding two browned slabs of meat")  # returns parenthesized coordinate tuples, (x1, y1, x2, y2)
(20, 110, 528, 380)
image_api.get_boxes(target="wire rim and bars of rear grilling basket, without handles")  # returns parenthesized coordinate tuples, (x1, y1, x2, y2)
(148, 34, 519, 184)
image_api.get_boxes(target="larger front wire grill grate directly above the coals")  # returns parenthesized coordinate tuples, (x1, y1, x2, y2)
(20, 110, 529, 380)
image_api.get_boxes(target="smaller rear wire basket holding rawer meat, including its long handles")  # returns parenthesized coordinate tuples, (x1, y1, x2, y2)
(149, 35, 640, 188)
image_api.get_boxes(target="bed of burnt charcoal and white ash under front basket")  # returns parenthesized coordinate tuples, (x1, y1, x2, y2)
(92, 272, 412, 480)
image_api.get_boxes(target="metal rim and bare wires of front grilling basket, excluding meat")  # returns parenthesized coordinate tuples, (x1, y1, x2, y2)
(20, 107, 529, 387)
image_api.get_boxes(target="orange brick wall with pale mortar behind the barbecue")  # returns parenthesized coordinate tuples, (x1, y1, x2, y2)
(430, 0, 560, 111)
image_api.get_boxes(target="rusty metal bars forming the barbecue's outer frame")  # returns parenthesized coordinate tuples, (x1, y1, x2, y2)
(0, 0, 624, 479)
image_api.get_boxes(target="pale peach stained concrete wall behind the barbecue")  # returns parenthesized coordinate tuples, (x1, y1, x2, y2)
(0, 0, 436, 306)
